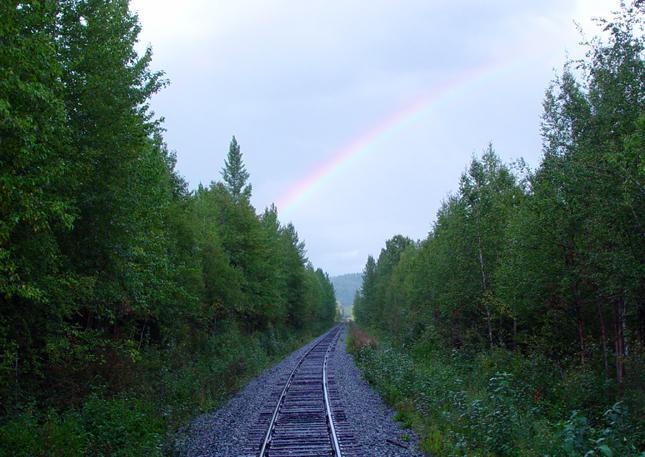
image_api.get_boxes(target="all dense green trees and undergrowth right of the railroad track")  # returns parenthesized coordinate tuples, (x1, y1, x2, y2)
(353, 2, 645, 456)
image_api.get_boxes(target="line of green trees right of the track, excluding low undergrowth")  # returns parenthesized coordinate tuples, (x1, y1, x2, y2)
(354, 2, 645, 455)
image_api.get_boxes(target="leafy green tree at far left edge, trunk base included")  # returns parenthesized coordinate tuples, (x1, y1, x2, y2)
(0, 2, 76, 409)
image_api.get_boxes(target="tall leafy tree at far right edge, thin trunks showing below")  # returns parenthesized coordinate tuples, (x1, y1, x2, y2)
(512, 2, 645, 382)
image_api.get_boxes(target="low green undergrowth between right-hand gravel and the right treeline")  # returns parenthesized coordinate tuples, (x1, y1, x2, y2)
(349, 331, 645, 457)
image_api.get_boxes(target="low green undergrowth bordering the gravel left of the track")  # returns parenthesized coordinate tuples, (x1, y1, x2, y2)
(0, 325, 309, 457)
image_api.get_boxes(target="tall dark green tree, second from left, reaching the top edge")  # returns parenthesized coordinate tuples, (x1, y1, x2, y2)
(50, 0, 173, 395)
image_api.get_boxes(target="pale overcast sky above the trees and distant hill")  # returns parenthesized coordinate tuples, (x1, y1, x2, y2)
(131, 0, 618, 275)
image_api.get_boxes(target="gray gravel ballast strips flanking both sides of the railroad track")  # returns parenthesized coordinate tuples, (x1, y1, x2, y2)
(175, 331, 423, 457)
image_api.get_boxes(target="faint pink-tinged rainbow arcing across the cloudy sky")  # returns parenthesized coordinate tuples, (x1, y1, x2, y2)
(277, 51, 533, 214)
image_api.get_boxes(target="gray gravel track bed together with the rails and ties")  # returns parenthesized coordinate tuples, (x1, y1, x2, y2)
(176, 327, 423, 457)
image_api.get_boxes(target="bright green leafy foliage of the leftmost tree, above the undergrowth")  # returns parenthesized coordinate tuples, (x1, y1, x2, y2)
(0, 2, 74, 300)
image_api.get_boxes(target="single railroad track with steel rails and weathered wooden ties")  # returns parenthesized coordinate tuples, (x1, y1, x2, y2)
(247, 326, 361, 457)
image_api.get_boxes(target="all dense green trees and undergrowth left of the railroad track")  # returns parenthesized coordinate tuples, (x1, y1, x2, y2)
(0, 0, 336, 456)
